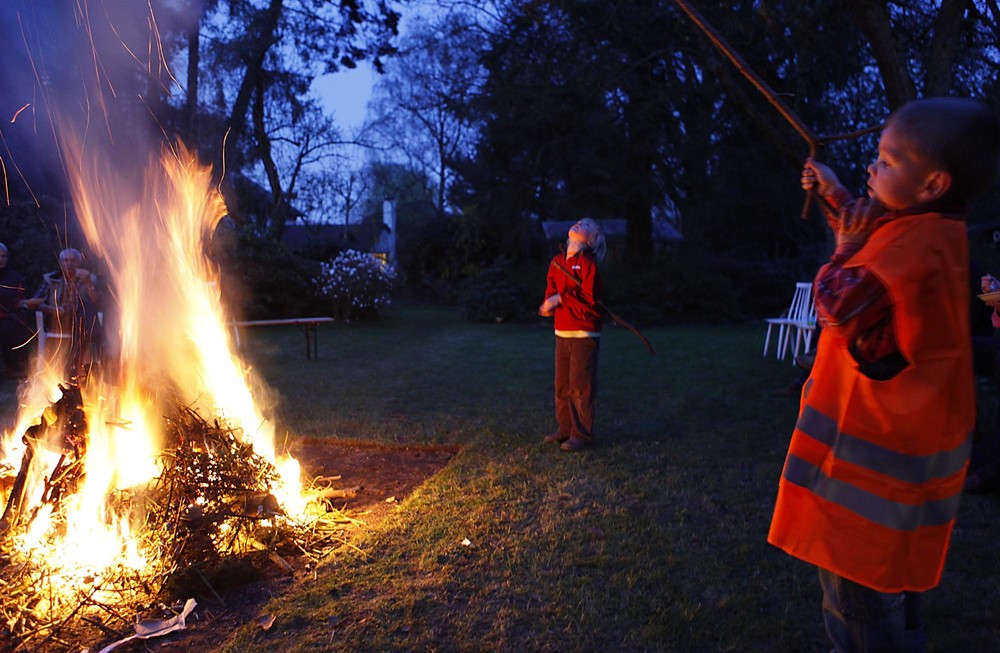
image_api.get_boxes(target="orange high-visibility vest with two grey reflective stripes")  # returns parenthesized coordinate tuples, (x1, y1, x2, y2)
(768, 213, 976, 592)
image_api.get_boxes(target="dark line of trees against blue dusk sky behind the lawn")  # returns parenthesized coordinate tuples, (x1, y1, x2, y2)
(0, 0, 1000, 322)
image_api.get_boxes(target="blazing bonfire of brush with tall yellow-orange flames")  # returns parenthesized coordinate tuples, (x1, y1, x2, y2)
(0, 146, 345, 653)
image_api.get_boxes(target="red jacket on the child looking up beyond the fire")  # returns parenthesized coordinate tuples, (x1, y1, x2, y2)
(545, 251, 603, 333)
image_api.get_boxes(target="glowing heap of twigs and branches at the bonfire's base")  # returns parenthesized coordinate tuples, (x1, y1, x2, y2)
(0, 387, 353, 653)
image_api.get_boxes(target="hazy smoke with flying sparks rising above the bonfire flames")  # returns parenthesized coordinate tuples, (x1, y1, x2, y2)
(0, 0, 201, 201)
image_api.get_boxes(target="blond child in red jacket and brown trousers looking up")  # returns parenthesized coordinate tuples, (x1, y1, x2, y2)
(538, 218, 607, 451)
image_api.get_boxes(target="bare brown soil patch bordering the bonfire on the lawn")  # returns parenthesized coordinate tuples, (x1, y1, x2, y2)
(98, 438, 459, 653)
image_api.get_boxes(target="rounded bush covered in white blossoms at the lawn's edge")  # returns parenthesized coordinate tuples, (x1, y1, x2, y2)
(316, 249, 396, 320)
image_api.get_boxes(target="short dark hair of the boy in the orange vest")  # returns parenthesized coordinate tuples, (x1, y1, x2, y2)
(886, 97, 1000, 204)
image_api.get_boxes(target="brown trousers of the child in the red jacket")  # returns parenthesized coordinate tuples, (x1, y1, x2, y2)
(556, 336, 601, 443)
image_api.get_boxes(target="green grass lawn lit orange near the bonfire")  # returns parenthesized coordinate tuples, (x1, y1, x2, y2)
(3, 306, 1000, 653)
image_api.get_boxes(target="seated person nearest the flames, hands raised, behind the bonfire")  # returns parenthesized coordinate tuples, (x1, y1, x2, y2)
(28, 248, 104, 376)
